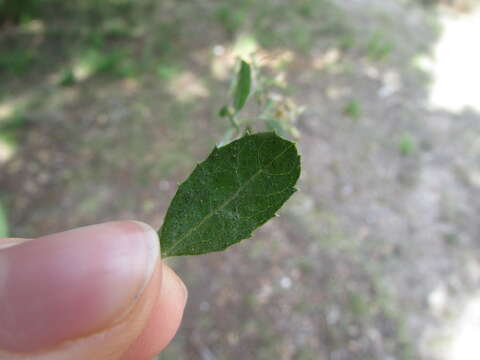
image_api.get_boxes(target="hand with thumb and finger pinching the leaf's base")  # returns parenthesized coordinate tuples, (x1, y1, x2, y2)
(0, 221, 187, 360)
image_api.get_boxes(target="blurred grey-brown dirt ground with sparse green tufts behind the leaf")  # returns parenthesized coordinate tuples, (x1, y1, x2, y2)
(0, 0, 480, 360)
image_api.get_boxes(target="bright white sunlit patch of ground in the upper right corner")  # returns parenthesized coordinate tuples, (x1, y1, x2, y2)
(430, 7, 480, 112)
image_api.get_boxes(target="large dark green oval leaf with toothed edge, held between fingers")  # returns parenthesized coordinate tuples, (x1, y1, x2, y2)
(160, 132, 300, 258)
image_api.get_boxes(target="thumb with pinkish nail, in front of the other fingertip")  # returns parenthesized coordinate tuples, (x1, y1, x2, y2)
(0, 221, 160, 353)
